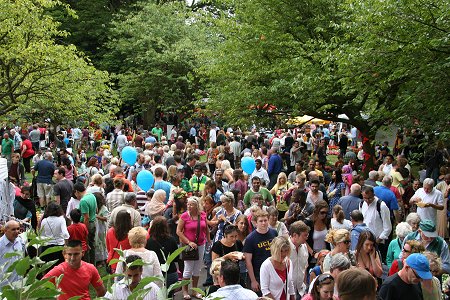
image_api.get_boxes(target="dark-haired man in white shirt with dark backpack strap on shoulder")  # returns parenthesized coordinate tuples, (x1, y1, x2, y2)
(359, 186, 392, 261)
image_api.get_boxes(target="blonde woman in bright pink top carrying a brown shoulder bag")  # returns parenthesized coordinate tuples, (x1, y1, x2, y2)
(177, 197, 211, 300)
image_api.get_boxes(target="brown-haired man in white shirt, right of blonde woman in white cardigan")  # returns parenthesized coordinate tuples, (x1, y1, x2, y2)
(289, 221, 310, 299)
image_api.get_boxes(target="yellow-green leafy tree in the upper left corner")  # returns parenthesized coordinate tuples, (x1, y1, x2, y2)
(0, 0, 117, 123)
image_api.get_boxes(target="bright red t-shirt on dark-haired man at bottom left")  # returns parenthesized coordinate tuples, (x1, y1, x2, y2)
(44, 261, 103, 300)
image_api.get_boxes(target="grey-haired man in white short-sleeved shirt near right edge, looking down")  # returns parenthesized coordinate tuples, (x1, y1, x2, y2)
(409, 178, 444, 224)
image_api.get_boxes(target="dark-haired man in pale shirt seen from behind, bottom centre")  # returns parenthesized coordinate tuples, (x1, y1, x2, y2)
(207, 260, 258, 300)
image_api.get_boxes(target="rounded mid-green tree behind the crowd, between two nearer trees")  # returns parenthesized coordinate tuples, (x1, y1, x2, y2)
(103, 2, 207, 125)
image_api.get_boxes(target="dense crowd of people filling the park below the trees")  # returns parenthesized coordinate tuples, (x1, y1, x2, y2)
(0, 124, 450, 300)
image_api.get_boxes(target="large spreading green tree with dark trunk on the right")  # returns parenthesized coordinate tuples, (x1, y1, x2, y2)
(203, 0, 450, 172)
